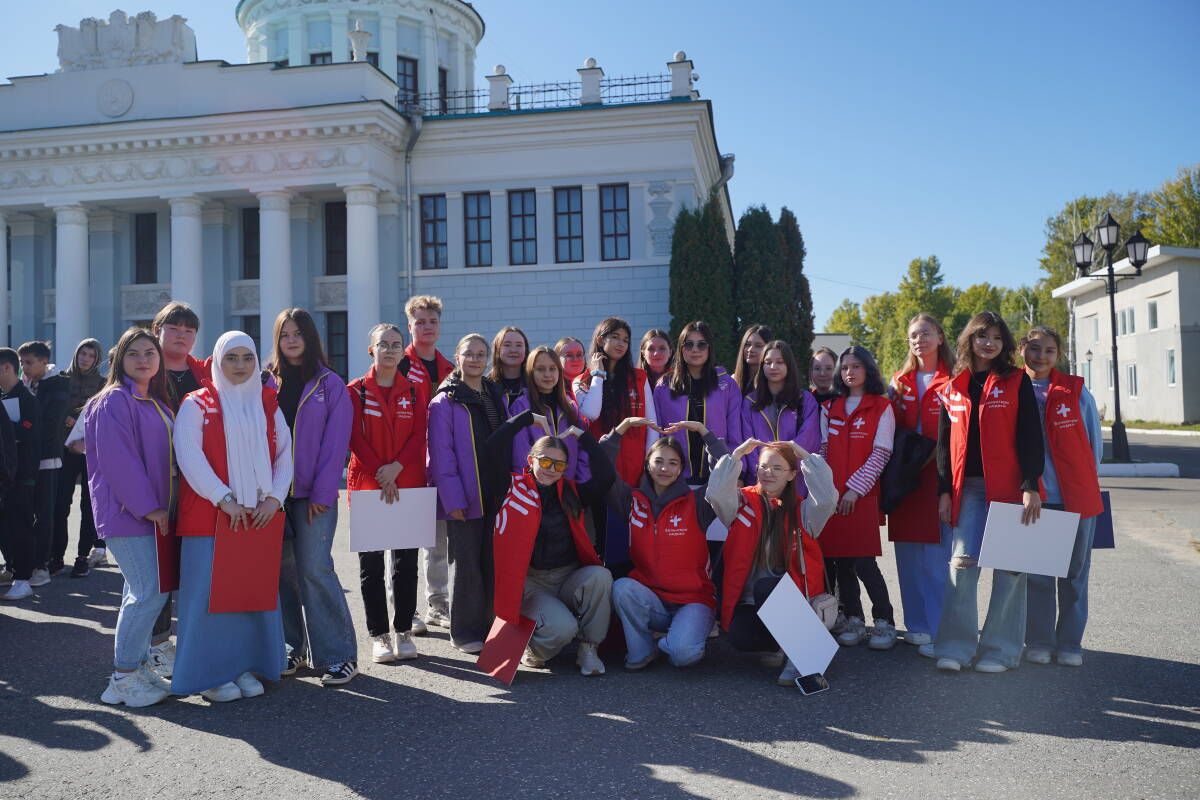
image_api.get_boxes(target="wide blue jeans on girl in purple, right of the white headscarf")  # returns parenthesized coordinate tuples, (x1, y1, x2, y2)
(280, 499, 359, 668)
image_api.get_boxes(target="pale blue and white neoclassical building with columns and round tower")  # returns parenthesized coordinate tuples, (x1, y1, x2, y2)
(0, 0, 732, 373)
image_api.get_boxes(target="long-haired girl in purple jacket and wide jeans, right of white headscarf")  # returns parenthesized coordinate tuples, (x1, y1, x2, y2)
(271, 308, 359, 686)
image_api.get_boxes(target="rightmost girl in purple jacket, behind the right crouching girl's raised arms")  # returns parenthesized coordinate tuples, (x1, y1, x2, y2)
(742, 339, 821, 491)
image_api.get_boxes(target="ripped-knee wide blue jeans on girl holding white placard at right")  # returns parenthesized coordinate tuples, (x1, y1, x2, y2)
(934, 477, 1028, 669)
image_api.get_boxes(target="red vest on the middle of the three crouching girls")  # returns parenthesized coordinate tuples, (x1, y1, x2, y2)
(629, 489, 716, 608)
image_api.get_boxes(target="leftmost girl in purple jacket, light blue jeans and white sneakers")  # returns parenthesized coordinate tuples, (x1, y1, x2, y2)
(83, 327, 175, 708)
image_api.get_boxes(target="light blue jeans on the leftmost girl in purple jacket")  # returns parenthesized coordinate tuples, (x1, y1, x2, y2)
(108, 536, 168, 672)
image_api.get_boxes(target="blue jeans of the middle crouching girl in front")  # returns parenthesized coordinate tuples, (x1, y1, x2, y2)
(612, 578, 714, 667)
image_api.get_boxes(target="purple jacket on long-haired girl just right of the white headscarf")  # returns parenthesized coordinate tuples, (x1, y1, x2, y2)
(292, 367, 354, 505)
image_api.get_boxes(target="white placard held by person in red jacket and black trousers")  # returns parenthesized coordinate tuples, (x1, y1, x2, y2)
(350, 486, 438, 553)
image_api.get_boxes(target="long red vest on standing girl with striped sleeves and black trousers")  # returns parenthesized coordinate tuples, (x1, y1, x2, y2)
(821, 395, 888, 558)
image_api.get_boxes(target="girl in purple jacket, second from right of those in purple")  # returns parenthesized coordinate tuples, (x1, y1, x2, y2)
(654, 320, 743, 486)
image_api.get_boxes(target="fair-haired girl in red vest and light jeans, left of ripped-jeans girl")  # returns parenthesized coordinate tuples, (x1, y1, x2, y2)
(888, 313, 954, 656)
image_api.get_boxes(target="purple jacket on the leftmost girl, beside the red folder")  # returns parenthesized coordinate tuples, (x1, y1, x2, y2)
(83, 381, 175, 539)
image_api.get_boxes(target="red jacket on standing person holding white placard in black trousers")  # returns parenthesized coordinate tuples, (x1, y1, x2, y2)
(346, 367, 427, 492)
